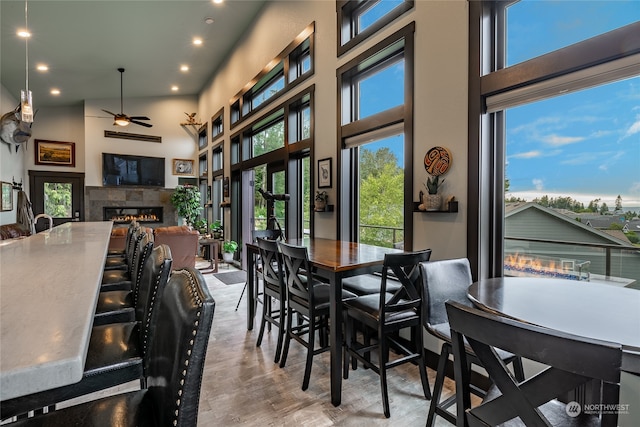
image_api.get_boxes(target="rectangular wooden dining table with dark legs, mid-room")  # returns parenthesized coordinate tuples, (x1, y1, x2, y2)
(246, 238, 402, 406)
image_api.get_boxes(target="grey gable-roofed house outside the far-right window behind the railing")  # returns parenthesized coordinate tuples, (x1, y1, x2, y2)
(504, 202, 640, 287)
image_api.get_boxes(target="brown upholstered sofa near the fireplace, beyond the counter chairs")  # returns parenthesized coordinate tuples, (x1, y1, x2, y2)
(153, 225, 200, 270)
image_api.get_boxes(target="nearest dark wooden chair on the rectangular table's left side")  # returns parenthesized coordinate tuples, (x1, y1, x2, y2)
(278, 241, 356, 390)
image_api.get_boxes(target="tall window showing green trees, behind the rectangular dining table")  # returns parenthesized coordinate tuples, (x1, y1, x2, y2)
(338, 24, 414, 249)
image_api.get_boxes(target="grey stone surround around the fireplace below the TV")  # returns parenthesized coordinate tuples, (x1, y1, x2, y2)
(85, 187, 178, 228)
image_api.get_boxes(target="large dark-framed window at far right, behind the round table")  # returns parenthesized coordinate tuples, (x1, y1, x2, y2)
(468, 1, 640, 287)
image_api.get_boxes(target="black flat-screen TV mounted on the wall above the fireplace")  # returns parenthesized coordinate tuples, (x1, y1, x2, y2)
(102, 153, 164, 187)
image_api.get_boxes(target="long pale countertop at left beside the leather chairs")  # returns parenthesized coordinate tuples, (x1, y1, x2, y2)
(0, 222, 113, 400)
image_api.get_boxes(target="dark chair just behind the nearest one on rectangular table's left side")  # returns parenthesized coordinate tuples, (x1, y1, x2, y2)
(256, 237, 287, 363)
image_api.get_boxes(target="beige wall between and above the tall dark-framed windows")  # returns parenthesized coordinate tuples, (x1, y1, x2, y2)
(198, 0, 468, 259)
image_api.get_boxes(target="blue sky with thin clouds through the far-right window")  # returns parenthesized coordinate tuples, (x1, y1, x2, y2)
(506, 0, 640, 208)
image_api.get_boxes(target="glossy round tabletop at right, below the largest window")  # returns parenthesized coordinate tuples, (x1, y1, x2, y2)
(468, 277, 640, 374)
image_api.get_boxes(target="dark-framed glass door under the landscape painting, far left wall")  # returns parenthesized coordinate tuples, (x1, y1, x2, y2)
(29, 170, 84, 232)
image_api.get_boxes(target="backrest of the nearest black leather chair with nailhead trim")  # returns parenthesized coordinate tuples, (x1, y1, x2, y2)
(147, 268, 215, 427)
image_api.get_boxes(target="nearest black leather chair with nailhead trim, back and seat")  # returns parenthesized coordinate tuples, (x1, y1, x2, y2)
(7, 268, 215, 427)
